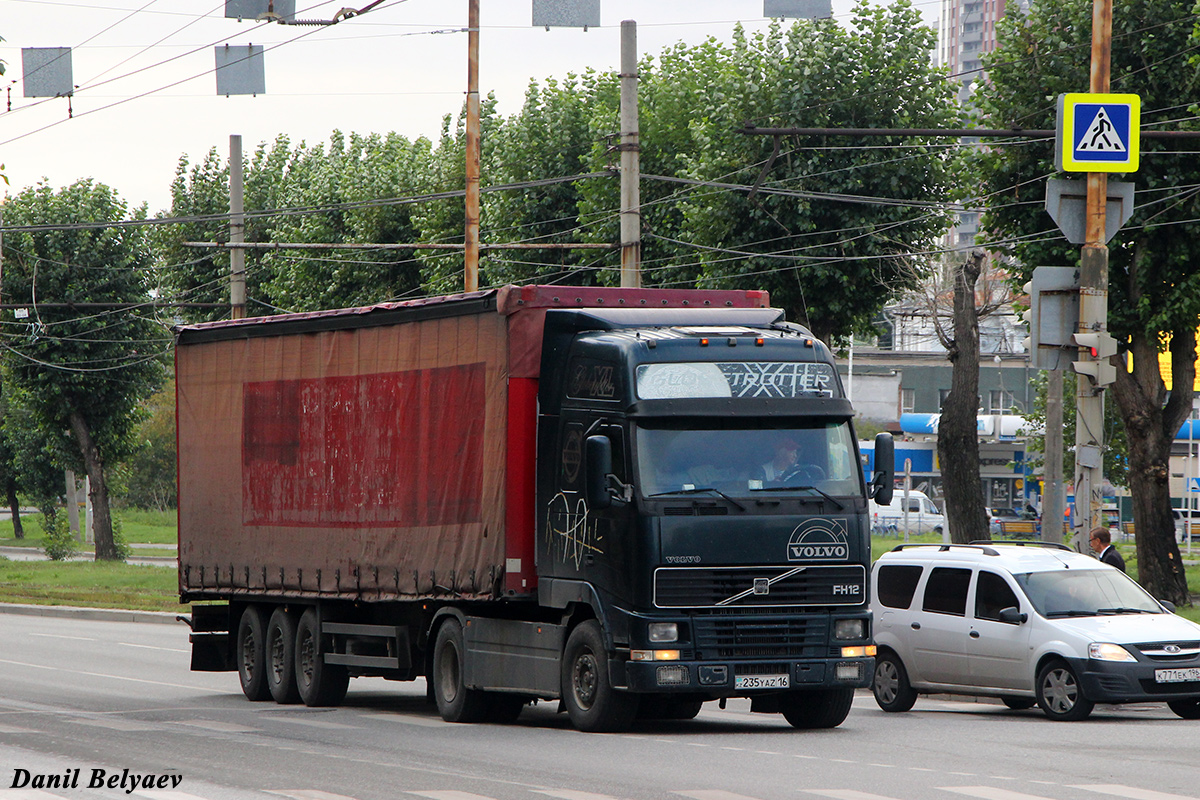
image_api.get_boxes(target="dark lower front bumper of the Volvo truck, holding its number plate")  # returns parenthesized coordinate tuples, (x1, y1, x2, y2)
(614, 657, 875, 697)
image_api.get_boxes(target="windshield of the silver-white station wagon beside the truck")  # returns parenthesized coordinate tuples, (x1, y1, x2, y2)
(1014, 570, 1164, 618)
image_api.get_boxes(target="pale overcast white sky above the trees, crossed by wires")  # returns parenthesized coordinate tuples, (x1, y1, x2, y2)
(0, 0, 938, 213)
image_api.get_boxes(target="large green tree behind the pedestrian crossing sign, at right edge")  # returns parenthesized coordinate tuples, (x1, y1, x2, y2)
(977, 0, 1200, 604)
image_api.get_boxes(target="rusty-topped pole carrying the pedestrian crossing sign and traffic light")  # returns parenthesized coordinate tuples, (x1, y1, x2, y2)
(1073, 0, 1112, 552)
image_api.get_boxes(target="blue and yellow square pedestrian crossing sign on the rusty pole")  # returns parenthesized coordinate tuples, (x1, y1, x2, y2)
(1055, 94, 1141, 173)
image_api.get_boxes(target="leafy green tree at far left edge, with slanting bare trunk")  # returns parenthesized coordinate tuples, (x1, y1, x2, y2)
(2, 180, 170, 560)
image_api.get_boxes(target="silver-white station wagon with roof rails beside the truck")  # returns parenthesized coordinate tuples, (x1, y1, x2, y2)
(871, 542, 1200, 720)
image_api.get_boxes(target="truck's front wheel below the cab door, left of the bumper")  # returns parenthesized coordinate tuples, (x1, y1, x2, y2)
(562, 620, 638, 732)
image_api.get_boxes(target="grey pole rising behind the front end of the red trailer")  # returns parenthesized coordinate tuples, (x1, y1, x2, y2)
(618, 19, 642, 288)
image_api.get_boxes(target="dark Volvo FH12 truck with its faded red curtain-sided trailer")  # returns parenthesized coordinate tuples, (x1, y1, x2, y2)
(175, 285, 894, 730)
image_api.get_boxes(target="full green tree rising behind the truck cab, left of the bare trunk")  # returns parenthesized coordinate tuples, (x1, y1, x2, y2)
(683, 0, 958, 343)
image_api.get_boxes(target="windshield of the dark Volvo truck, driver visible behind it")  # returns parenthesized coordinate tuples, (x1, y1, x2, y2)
(636, 420, 863, 497)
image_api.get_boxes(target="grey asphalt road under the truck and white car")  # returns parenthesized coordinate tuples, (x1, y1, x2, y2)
(0, 613, 1200, 800)
